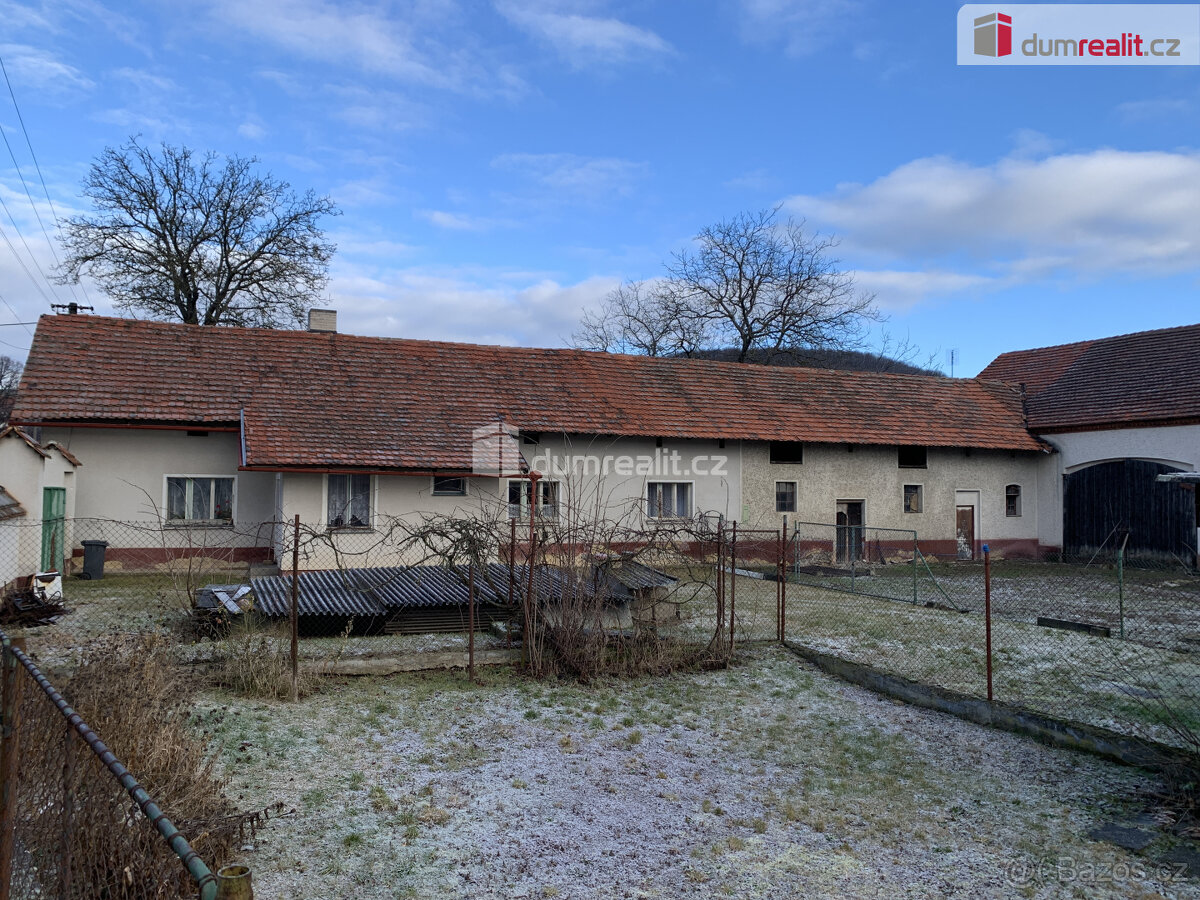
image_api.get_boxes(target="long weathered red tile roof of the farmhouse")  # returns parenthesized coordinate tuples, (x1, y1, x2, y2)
(13, 316, 1042, 469)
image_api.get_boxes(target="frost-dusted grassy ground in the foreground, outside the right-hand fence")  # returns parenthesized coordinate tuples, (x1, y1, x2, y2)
(197, 647, 1200, 900)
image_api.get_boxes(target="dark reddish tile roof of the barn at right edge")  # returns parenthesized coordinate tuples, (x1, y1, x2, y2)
(979, 325, 1200, 432)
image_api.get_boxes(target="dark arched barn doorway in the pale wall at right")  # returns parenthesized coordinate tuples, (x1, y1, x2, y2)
(1062, 460, 1196, 562)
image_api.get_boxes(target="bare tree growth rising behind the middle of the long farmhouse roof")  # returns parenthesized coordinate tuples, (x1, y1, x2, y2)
(575, 208, 881, 362)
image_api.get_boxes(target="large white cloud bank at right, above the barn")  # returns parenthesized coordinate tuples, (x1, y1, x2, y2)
(786, 150, 1200, 280)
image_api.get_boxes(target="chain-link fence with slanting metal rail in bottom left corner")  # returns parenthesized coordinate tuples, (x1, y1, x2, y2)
(0, 635, 242, 900)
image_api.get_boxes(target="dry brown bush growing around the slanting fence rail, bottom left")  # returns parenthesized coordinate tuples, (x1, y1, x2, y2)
(18, 635, 272, 898)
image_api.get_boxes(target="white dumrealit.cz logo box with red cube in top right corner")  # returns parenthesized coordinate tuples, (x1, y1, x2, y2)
(958, 4, 1200, 66)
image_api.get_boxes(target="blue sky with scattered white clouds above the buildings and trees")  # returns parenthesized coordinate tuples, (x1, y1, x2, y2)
(0, 0, 1200, 376)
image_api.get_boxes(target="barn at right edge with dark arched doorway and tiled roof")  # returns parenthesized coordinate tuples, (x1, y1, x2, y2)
(979, 325, 1200, 563)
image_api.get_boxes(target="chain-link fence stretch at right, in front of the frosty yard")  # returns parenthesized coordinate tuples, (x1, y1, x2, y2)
(787, 526, 1200, 750)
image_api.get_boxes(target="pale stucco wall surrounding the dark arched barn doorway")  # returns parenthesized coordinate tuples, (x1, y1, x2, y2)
(1038, 425, 1200, 547)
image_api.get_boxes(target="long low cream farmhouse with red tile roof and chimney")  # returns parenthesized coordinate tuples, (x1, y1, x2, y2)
(13, 311, 1048, 578)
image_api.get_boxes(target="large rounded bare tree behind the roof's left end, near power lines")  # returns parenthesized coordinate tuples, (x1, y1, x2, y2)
(60, 138, 337, 326)
